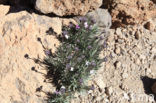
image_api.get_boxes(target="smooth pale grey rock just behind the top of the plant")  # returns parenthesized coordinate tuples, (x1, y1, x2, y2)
(87, 8, 112, 28)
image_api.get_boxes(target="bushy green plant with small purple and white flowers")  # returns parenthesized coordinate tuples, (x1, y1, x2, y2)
(45, 17, 106, 103)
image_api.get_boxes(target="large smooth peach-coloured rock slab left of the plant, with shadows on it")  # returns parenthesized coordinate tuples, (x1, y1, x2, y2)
(0, 11, 74, 103)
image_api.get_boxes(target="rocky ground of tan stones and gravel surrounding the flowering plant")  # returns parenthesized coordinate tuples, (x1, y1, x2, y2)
(0, 0, 156, 103)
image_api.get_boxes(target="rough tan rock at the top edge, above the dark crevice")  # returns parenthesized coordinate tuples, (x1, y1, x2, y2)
(35, 0, 102, 16)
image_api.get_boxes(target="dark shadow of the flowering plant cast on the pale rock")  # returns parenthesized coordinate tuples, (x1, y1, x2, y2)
(24, 35, 62, 100)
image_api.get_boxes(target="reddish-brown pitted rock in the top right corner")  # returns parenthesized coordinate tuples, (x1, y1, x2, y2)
(104, 0, 156, 27)
